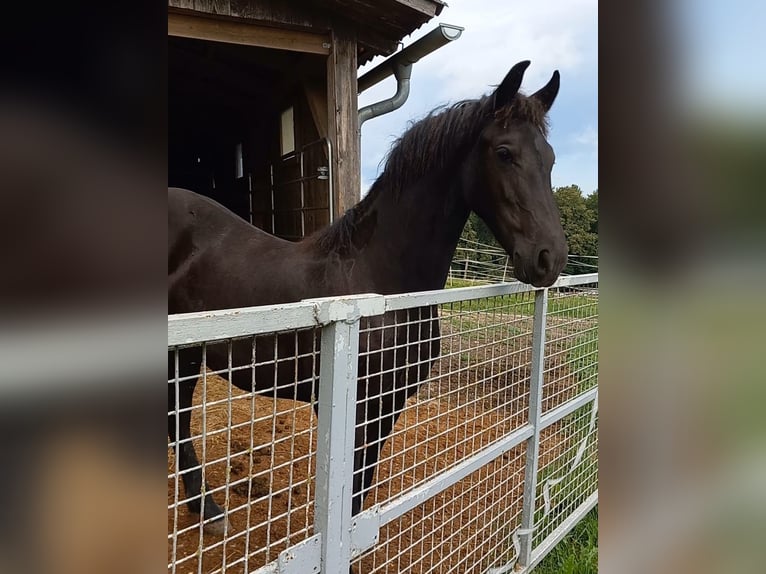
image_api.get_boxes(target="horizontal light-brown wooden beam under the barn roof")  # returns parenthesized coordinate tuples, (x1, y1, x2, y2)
(168, 12, 330, 55)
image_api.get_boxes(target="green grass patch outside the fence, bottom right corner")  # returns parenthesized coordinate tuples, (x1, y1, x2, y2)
(533, 506, 598, 574)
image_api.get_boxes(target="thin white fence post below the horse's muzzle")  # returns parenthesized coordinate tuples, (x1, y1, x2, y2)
(517, 289, 548, 570)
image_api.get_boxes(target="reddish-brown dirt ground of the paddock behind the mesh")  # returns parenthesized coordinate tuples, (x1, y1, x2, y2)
(168, 316, 592, 574)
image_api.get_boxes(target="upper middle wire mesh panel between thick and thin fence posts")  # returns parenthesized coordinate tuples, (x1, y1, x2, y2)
(356, 293, 534, 507)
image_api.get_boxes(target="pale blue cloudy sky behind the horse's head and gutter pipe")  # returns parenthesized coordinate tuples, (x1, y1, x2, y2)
(359, 0, 598, 195)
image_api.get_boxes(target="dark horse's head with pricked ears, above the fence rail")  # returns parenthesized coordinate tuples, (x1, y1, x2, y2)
(464, 61, 567, 287)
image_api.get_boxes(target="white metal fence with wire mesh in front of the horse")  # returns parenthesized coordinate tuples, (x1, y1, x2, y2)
(168, 274, 598, 574)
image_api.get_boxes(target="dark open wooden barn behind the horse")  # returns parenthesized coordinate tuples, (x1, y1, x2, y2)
(168, 0, 444, 240)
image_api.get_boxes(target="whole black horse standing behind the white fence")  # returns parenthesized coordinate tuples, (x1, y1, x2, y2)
(168, 61, 567, 532)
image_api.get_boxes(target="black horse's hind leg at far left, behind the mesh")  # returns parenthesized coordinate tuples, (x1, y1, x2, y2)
(168, 349, 225, 535)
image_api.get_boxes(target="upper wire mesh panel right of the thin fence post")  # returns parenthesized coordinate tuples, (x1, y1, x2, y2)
(543, 283, 598, 413)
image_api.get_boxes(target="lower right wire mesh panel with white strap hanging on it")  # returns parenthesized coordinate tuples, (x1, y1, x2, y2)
(533, 401, 598, 546)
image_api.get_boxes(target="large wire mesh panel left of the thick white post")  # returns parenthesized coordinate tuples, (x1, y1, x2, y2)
(168, 329, 319, 573)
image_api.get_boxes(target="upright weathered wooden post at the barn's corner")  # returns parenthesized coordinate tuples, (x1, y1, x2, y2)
(327, 25, 361, 218)
